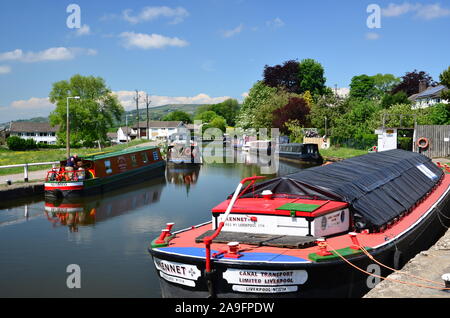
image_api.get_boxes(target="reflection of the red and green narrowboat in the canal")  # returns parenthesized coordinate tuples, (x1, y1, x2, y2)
(45, 178, 166, 232)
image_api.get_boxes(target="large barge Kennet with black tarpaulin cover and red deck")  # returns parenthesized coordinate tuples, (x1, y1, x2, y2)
(149, 150, 450, 297)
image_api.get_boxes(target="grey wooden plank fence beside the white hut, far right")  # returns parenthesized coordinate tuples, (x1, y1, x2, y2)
(413, 125, 450, 158)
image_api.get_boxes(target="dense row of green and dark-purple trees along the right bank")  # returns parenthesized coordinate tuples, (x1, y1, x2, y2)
(236, 59, 450, 148)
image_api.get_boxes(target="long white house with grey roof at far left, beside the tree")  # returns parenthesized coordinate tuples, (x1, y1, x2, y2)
(9, 122, 59, 145)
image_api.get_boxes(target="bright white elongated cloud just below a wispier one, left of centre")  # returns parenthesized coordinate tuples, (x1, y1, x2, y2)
(119, 32, 189, 50)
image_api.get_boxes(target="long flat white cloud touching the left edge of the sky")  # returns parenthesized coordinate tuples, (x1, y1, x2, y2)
(0, 47, 97, 63)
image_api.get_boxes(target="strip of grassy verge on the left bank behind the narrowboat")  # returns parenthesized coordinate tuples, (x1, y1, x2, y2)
(0, 140, 151, 176)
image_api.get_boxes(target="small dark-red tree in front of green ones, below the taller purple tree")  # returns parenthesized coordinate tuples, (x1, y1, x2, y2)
(273, 97, 309, 134)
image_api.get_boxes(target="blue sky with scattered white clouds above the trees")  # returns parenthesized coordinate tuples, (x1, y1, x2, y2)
(0, 0, 450, 123)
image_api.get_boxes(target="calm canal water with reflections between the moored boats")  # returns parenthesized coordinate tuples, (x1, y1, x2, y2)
(0, 154, 316, 298)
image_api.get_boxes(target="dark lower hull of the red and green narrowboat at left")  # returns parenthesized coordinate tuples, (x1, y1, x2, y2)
(44, 161, 165, 199)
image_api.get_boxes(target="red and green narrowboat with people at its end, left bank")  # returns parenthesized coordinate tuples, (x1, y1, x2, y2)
(44, 147, 165, 198)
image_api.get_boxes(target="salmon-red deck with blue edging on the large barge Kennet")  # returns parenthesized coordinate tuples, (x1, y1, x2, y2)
(154, 174, 450, 262)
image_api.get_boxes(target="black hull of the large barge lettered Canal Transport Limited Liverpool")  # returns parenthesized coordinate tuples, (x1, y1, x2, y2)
(149, 186, 450, 298)
